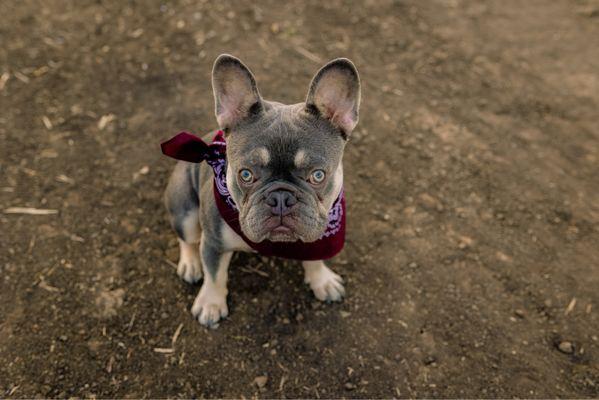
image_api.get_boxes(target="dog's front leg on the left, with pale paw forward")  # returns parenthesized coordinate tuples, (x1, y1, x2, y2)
(191, 233, 233, 328)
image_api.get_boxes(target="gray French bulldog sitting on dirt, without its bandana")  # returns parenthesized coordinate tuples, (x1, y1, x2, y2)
(165, 55, 360, 327)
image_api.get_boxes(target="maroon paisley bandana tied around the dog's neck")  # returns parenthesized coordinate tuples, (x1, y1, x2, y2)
(160, 131, 345, 261)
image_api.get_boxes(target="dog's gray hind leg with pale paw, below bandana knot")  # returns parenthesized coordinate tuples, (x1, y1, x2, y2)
(164, 162, 202, 283)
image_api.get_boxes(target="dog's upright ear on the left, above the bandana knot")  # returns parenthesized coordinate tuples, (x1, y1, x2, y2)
(212, 54, 262, 130)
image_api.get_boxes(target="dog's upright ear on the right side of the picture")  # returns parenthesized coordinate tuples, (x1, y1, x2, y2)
(306, 58, 360, 135)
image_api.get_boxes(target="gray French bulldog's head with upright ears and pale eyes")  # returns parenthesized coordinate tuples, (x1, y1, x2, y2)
(212, 55, 360, 242)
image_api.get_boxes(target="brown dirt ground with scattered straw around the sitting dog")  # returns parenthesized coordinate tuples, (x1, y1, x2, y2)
(0, 0, 599, 398)
